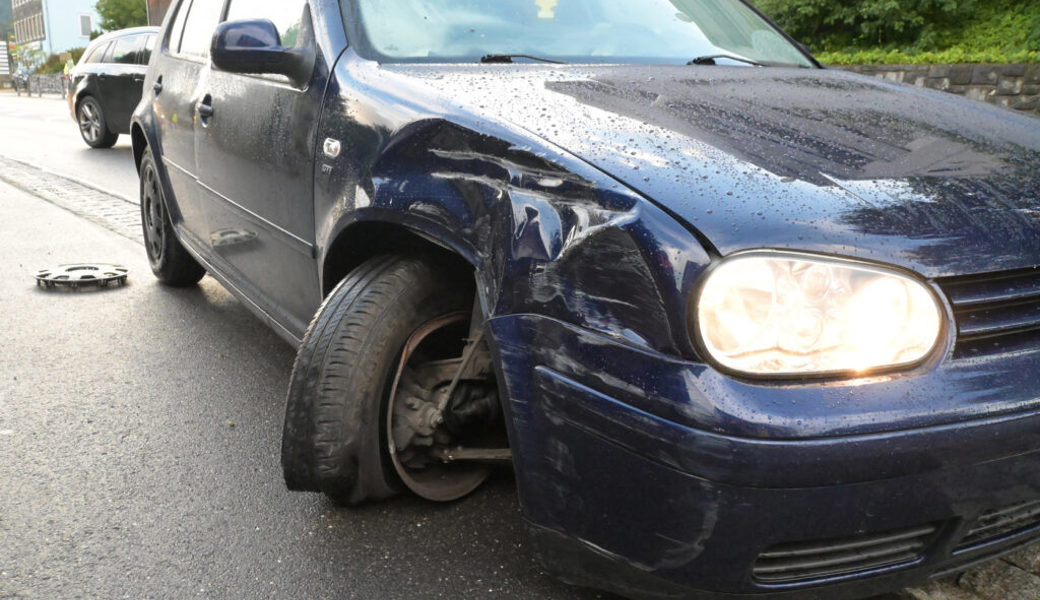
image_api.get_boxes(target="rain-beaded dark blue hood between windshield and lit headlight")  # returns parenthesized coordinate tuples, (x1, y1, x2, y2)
(383, 66, 1040, 277)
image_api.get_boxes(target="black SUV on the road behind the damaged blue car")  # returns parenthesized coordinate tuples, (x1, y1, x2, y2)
(68, 27, 159, 148)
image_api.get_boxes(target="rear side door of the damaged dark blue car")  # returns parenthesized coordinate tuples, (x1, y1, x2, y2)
(152, 0, 224, 245)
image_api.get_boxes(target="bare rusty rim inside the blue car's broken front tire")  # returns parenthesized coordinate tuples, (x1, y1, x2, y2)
(386, 313, 491, 502)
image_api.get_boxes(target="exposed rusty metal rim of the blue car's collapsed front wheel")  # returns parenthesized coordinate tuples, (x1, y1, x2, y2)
(386, 312, 491, 502)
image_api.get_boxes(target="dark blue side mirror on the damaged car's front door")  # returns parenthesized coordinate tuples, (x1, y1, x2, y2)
(210, 14, 314, 85)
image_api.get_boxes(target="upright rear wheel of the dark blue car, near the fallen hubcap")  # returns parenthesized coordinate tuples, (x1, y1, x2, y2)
(139, 149, 206, 287)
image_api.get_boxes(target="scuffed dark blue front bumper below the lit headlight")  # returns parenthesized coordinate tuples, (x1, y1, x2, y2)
(490, 315, 1040, 598)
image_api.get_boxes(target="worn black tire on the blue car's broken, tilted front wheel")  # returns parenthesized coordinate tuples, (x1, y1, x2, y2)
(282, 256, 468, 504)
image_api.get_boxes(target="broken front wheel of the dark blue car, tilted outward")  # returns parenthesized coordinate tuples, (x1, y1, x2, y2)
(282, 256, 501, 504)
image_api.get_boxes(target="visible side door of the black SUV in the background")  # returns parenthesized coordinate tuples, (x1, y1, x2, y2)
(98, 34, 146, 133)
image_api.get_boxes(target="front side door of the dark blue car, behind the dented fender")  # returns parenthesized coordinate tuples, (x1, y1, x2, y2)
(196, 0, 328, 337)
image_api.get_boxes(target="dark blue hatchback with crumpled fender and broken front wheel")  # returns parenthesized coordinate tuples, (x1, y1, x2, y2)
(131, 0, 1040, 598)
